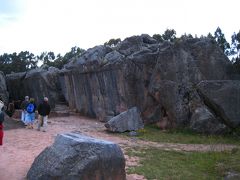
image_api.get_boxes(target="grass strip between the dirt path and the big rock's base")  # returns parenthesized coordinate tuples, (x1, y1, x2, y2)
(129, 125, 240, 145)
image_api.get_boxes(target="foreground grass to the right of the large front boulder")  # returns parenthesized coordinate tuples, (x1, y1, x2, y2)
(127, 148, 240, 180)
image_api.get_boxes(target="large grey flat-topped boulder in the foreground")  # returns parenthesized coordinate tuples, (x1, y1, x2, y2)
(27, 133, 126, 180)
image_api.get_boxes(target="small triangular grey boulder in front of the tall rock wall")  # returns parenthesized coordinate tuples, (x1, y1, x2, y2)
(105, 107, 144, 132)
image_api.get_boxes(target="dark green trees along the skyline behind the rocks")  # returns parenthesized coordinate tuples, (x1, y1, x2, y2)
(0, 27, 240, 74)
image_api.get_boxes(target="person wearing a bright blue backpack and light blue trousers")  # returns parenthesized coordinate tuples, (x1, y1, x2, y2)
(25, 98, 37, 129)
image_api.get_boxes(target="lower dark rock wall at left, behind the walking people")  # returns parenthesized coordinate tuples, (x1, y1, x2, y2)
(6, 68, 62, 107)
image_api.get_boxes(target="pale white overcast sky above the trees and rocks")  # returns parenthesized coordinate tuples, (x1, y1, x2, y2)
(0, 0, 240, 55)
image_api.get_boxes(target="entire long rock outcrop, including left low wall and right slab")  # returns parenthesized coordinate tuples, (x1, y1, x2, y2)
(4, 35, 240, 134)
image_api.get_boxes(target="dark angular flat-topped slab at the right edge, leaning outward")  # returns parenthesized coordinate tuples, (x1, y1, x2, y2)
(197, 80, 240, 128)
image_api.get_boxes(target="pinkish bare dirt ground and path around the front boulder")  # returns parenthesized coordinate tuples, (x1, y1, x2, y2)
(0, 116, 235, 180)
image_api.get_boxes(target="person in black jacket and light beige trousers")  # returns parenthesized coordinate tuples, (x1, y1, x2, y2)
(37, 97, 51, 132)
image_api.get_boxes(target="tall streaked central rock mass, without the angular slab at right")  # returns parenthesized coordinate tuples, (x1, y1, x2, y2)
(61, 35, 238, 134)
